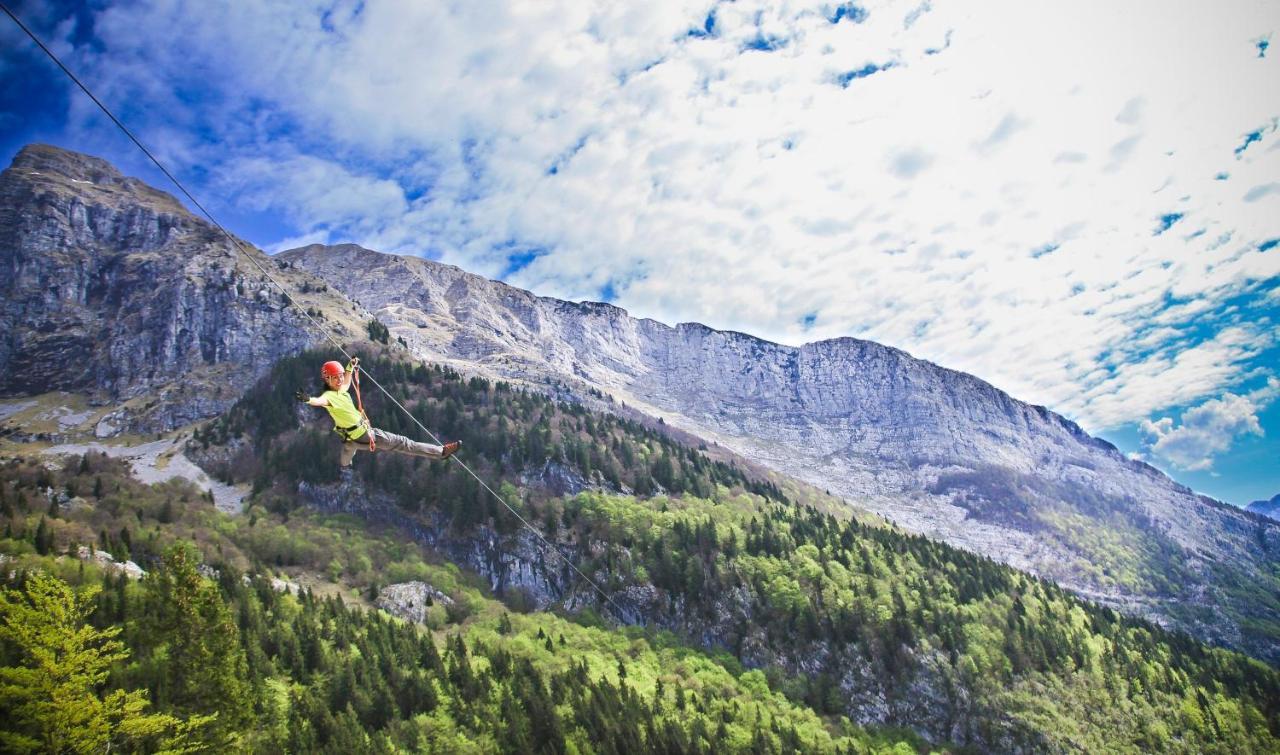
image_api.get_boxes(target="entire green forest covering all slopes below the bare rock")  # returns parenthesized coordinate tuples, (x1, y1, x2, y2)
(0, 354, 1280, 752)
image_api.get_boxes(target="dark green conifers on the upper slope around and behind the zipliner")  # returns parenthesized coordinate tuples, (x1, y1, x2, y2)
(197, 352, 785, 524)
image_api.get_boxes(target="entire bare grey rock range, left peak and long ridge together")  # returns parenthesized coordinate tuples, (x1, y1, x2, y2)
(0, 146, 1280, 662)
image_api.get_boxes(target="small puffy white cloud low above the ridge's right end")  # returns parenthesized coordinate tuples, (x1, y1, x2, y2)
(1140, 378, 1280, 471)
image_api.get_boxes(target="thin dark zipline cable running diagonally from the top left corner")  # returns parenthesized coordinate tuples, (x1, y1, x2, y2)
(0, 0, 626, 621)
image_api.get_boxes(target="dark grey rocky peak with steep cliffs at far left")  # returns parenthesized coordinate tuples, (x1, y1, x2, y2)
(0, 145, 325, 435)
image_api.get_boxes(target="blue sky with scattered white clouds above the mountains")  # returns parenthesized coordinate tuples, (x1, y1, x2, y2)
(0, 0, 1280, 504)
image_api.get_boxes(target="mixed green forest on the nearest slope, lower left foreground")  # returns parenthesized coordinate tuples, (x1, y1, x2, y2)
(0, 454, 923, 752)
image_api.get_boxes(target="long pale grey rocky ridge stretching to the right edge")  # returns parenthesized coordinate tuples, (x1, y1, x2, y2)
(276, 244, 1280, 660)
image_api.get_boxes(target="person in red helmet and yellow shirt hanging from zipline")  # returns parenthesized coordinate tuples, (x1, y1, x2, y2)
(293, 357, 462, 476)
